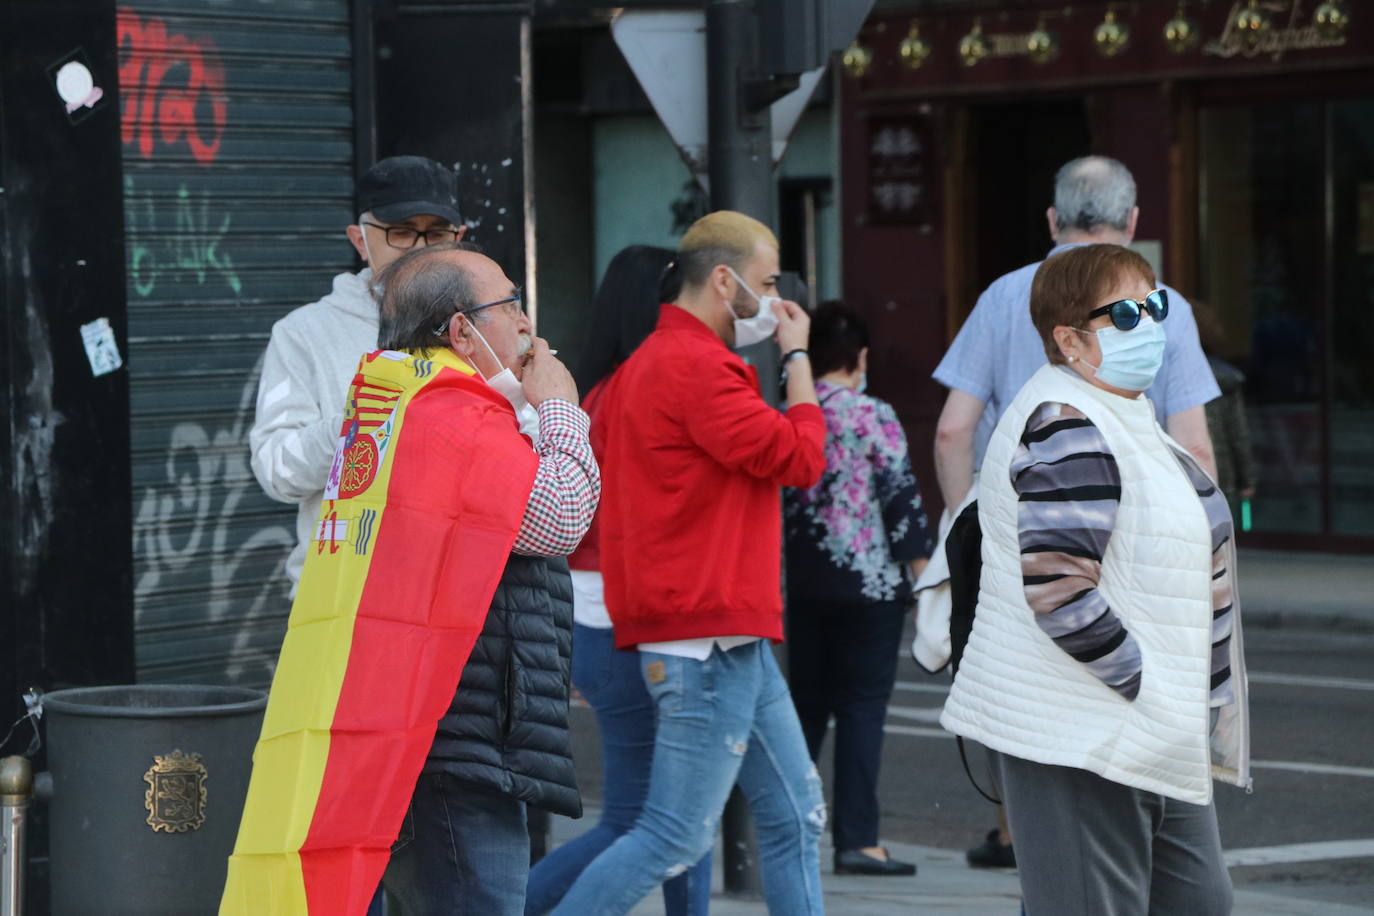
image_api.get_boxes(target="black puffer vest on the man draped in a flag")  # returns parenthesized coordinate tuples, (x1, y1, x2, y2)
(425, 553, 583, 817)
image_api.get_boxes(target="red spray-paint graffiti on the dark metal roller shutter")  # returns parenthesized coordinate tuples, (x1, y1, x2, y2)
(118, 7, 228, 165)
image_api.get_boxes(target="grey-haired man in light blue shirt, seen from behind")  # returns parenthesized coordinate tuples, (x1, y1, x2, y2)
(934, 155, 1220, 867)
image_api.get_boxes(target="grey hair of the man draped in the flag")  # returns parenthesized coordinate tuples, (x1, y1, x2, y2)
(376, 242, 481, 357)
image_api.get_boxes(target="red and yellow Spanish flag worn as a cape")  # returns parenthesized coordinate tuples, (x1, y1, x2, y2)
(220, 350, 539, 916)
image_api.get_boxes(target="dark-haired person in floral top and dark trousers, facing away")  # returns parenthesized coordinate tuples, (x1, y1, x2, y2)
(783, 302, 933, 875)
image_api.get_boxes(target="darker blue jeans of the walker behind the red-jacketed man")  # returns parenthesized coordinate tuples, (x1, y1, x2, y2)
(525, 625, 710, 916)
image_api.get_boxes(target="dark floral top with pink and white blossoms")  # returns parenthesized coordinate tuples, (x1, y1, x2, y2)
(783, 382, 934, 604)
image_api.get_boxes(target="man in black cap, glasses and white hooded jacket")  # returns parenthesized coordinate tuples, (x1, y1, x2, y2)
(249, 155, 467, 592)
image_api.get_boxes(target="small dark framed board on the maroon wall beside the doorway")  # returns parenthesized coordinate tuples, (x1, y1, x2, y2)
(868, 114, 932, 225)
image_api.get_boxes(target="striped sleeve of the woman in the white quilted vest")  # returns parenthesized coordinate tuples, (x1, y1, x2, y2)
(1011, 404, 1140, 700)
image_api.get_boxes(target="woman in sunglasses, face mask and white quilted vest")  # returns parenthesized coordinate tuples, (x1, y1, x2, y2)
(940, 244, 1250, 916)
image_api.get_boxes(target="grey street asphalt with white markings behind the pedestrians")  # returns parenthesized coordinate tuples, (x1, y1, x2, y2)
(554, 551, 1374, 916)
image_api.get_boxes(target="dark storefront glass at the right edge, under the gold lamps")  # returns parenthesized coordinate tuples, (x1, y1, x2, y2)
(1200, 102, 1374, 536)
